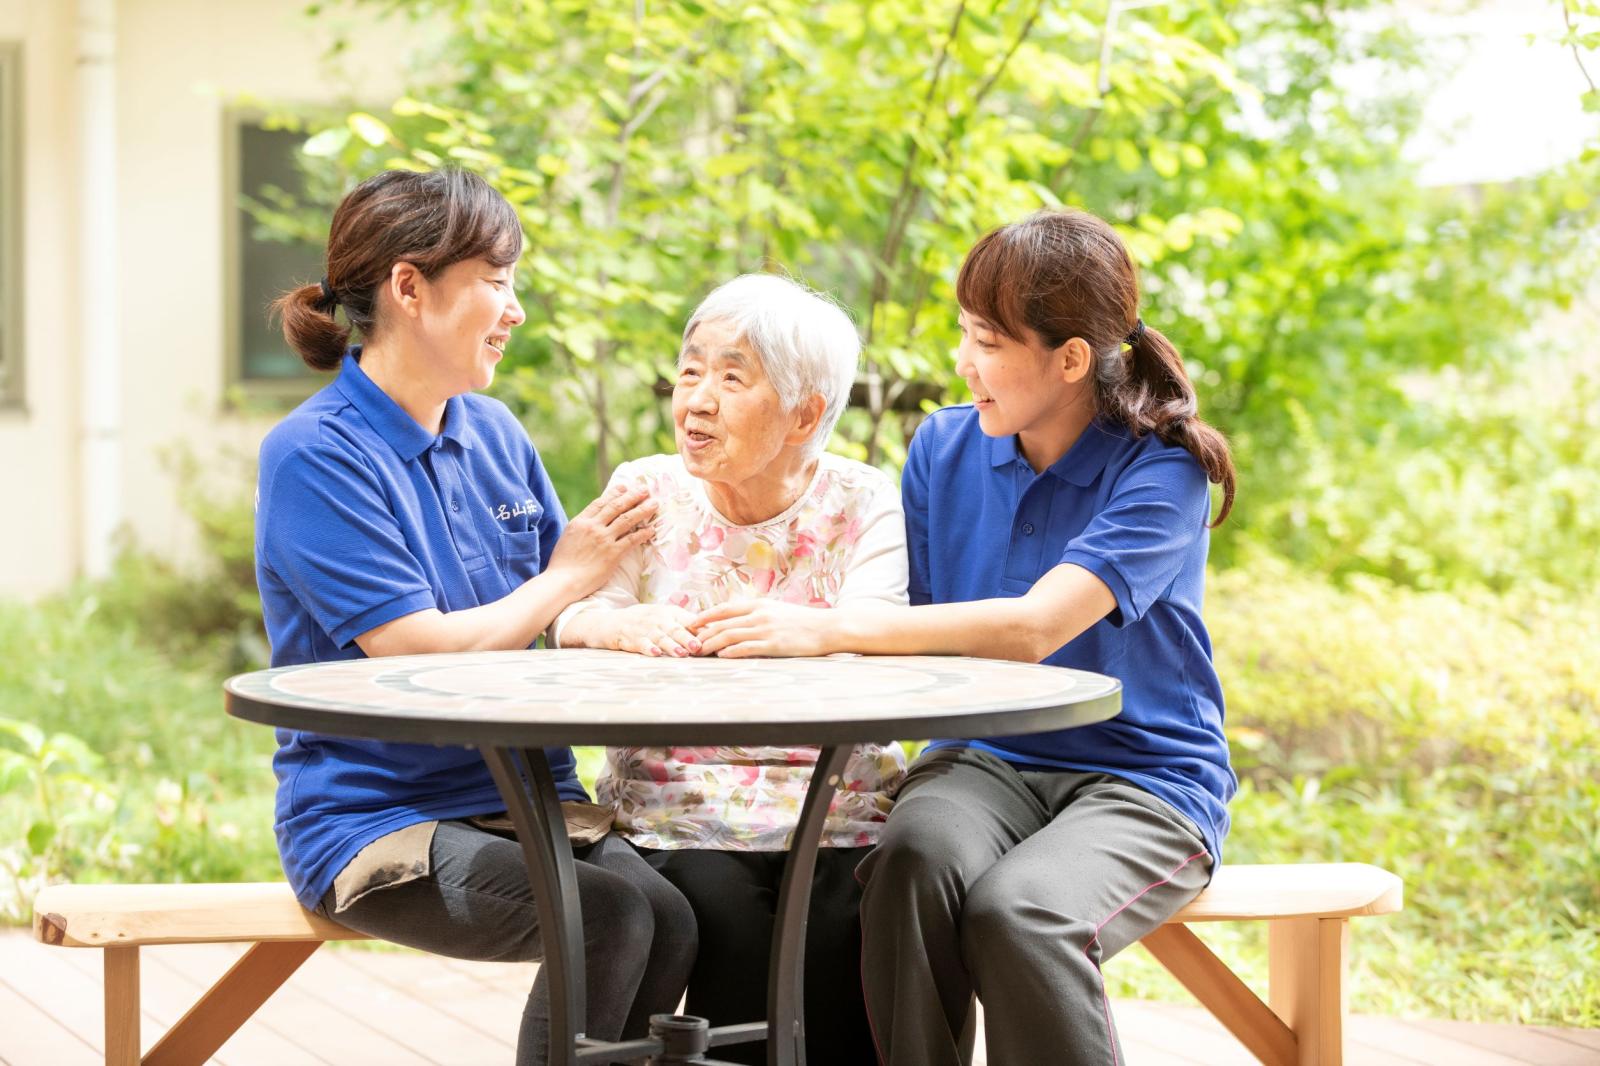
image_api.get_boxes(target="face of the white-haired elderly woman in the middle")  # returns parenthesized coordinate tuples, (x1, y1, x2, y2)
(672, 320, 798, 485)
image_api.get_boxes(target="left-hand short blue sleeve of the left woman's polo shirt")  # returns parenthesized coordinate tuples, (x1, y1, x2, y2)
(258, 447, 437, 648)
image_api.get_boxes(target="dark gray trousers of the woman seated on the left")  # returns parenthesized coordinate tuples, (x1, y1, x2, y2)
(323, 821, 696, 1066)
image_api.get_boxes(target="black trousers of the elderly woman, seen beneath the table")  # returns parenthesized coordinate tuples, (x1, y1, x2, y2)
(638, 848, 877, 1066)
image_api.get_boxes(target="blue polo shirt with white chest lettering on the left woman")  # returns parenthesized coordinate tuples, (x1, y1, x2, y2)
(256, 349, 587, 908)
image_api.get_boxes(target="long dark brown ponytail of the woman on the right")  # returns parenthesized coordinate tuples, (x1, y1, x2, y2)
(1120, 320, 1238, 528)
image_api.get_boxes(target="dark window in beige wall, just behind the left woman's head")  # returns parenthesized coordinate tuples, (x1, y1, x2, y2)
(229, 115, 323, 394)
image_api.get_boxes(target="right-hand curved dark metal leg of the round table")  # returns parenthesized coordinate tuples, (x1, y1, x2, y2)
(766, 744, 854, 1066)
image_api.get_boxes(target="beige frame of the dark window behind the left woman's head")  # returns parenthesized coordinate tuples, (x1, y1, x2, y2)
(221, 107, 331, 410)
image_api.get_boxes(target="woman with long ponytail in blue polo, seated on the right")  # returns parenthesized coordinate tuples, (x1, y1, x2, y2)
(696, 211, 1235, 1066)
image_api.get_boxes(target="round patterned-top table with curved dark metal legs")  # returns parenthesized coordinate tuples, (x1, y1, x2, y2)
(224, 650, 1122, 1066)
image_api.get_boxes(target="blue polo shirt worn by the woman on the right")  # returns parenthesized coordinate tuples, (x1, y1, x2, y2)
(901, 403, 1237, 869)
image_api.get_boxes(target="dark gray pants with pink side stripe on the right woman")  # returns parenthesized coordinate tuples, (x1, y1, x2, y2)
(856, 749, 1211, 1066)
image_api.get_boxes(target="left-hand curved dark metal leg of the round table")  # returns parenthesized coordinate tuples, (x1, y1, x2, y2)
(483, 747, 587, 1066)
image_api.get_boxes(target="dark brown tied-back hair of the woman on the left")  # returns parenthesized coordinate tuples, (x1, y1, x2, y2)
(272, 170, 522, 370)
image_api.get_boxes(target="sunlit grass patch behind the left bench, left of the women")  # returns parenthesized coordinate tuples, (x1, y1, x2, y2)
(0, 557, 278, 920)
